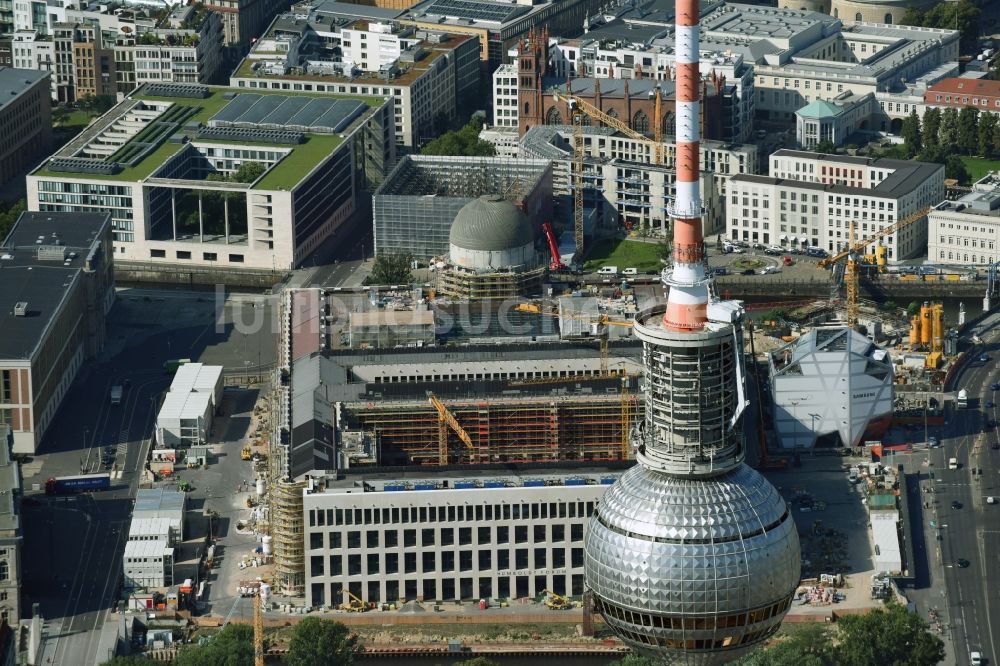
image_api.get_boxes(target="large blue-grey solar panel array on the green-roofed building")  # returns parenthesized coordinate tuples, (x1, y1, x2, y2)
(208, 93, 368, 133)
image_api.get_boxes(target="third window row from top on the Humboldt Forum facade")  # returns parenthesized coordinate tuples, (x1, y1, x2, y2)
(320, 548, 583, 578)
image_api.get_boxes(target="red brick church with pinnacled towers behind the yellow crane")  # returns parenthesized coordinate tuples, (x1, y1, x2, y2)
(518, 29, 725, 140)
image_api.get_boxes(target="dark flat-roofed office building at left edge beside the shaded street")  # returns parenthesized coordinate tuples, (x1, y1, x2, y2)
(0, 213, 115, 455)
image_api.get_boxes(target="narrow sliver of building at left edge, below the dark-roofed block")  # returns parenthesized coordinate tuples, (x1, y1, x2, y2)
(0, 423, 24, 627)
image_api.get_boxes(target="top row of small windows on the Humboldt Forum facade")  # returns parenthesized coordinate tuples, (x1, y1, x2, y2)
(309, 501, 594, 527)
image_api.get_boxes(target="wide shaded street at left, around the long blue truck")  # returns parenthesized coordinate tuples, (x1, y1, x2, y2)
(15, 289, 276, 664)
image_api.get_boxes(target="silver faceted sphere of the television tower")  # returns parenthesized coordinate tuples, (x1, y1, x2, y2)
(584, 464, 801, 666)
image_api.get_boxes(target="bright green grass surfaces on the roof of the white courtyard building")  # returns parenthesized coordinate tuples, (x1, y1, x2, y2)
(34, 88, 383, 190)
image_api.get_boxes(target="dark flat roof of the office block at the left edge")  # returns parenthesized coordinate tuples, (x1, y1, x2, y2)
(0, 213, 111, 360)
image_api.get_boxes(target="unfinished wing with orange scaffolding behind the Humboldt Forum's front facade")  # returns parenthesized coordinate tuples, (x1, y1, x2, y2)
(302, 341, 641, 467)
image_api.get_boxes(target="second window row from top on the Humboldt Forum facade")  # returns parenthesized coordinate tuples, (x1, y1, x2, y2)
(309, 523, 583, 550)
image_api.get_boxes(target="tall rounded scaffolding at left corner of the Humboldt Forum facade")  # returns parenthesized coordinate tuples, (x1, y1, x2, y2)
(271, 480, 306, 597)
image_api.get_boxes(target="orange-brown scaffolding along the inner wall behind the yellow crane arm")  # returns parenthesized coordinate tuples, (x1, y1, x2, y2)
(343, 386, 641, 465)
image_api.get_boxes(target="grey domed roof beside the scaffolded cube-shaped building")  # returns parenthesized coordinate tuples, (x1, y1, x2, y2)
(448, 194, 535, 251)
